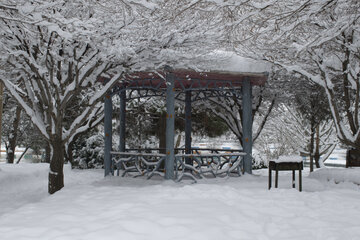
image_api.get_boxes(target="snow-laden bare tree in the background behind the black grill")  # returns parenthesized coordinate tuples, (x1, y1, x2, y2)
(255, 104, 338, 167)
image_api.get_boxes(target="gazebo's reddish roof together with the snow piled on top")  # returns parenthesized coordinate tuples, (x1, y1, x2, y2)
(99, 51, 271, 89)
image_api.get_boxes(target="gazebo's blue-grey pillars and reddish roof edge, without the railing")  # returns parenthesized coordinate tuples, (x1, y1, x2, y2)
(104, 67, 268, 179)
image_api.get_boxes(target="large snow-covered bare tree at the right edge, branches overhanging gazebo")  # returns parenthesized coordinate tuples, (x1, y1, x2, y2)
(233, 0, 360, 155)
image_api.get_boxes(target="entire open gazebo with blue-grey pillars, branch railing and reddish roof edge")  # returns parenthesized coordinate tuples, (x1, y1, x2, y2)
(104, 63, 268, 179)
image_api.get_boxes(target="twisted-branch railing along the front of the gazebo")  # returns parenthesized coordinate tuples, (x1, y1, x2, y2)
(111, 148, 246, 182)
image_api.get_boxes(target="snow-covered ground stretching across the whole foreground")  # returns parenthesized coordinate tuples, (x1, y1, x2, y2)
(0, 163, 360, 240)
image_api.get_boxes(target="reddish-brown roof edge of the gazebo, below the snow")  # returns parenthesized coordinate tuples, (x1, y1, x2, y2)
(109, 69, 268, 89)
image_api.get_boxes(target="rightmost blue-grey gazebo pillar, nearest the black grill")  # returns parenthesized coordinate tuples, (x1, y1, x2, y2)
(242, 79, 252, 174)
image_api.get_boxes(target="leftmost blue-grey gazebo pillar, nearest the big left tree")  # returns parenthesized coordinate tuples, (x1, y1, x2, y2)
(104, 94, 112, 176)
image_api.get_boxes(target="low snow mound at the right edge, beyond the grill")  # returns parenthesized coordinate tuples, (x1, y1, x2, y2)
(309, 168, 360, 185)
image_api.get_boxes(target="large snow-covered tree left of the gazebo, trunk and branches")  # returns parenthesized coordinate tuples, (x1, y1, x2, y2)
(0, 0, 238, 193)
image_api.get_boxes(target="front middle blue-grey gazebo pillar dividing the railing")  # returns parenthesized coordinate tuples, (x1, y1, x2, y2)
(165, 66, 175, 179)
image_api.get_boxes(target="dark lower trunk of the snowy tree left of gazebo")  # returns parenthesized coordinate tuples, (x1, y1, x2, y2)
(48, 138, 64, 194)
